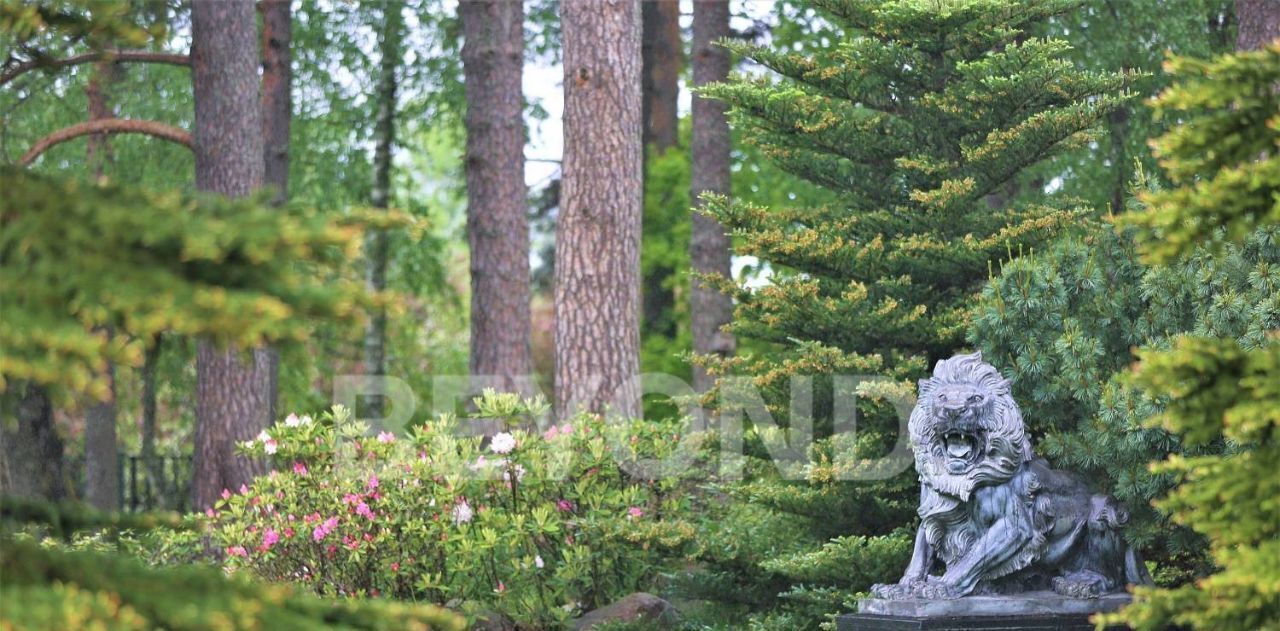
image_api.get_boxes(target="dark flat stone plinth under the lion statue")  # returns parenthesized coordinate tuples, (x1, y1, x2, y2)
(836, 591, 1130, 631)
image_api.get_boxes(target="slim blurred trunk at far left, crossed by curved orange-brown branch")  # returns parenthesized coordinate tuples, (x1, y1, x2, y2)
(84, 63, 120, 511)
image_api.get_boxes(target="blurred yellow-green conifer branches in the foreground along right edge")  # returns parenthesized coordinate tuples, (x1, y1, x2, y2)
(1090, 45, 1280, 630)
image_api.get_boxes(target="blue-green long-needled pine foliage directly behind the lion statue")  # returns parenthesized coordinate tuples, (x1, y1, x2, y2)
(969, 208, 1280, 582)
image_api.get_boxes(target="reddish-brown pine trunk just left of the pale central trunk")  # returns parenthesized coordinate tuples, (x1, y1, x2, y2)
(458, 0, 534, 394)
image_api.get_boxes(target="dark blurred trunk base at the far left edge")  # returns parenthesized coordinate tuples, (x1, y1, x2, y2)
(0, 384, 67, 500)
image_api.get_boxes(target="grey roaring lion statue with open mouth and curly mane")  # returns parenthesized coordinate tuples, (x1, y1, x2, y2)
(872, 353, 1151, 599)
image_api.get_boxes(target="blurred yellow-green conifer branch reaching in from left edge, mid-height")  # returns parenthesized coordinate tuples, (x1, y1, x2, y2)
(0, 169, 402, 398)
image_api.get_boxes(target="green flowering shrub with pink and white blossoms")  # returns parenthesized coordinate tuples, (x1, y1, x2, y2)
(207, 392, 692, 627)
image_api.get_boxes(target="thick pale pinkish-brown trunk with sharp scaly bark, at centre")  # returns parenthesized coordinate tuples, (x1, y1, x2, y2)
(556, 0, 644, 416)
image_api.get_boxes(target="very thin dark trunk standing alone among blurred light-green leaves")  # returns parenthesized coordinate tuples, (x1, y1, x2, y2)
(362, 0, 403, 419)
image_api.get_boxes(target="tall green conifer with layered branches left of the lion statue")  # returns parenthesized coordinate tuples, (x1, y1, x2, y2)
(698, 0, 1128, 626)
